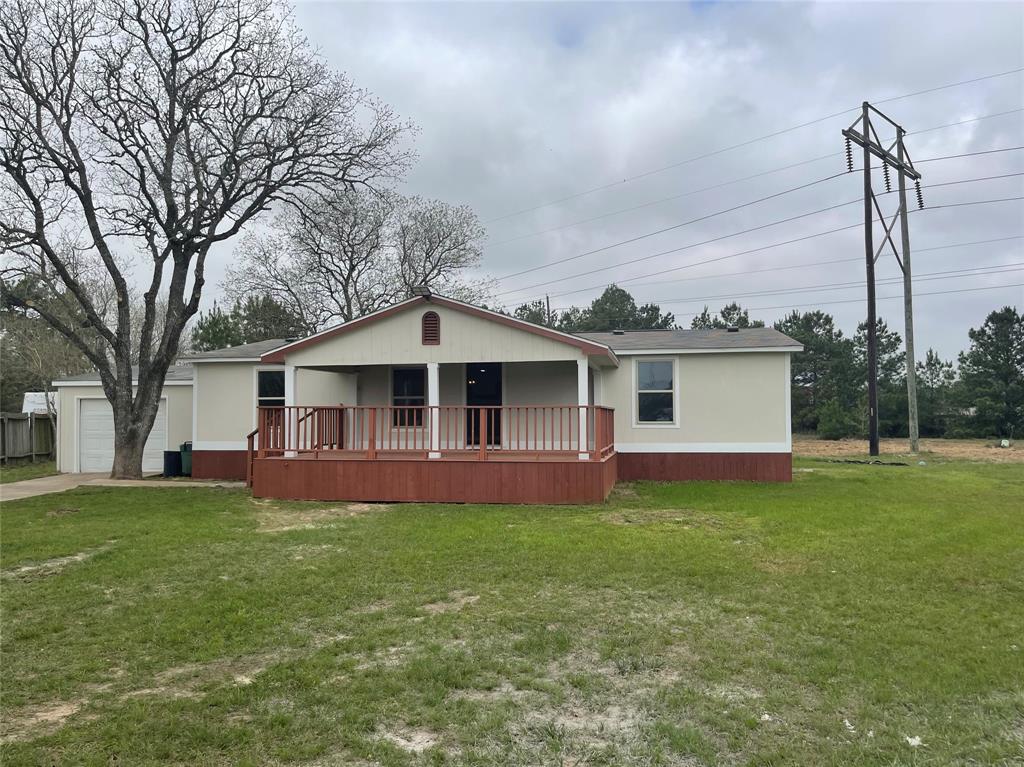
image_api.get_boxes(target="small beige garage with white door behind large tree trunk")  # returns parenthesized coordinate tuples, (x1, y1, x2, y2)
(53, 366, 193, 473)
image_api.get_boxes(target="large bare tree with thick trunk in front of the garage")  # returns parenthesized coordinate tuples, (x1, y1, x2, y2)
(0, 0, 408, 477)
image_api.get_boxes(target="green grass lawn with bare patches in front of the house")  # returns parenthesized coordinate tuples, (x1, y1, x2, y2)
(0, 461, 1024, 767)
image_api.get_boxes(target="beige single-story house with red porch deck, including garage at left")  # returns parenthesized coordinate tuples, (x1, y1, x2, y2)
(56, 295, 802, 503)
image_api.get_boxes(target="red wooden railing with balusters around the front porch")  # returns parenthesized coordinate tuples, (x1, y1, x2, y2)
(253, 404, 615, 461)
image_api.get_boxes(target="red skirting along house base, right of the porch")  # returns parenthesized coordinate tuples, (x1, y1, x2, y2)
(618, 453, 793, 482)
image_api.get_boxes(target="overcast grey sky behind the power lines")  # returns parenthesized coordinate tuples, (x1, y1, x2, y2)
(213, 2, 1024, 357)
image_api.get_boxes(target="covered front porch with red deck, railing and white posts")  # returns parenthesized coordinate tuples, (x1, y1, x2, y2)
(248, 358, 615, 503)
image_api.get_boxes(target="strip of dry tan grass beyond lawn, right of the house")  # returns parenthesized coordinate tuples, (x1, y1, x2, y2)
(793, 436, 1024, 464)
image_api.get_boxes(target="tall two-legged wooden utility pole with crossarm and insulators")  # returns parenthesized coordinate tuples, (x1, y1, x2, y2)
(843, 101, 925, 456)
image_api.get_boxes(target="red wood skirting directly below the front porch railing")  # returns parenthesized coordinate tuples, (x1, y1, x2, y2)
(251, 454, 617, 504)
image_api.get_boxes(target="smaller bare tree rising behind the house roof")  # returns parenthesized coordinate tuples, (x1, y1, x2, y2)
(223, 189, 490, 333)
